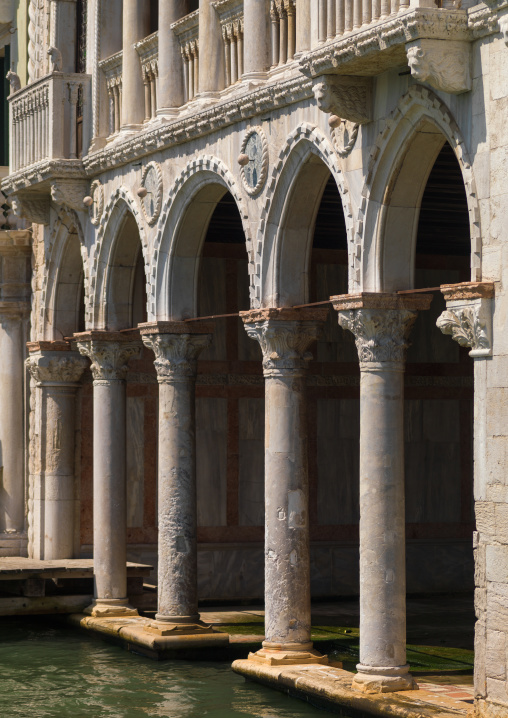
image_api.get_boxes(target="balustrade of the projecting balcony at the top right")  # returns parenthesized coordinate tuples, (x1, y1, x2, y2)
(317, 0, 410, 42)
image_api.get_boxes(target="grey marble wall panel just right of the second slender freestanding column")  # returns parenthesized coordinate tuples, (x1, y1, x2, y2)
(196, 397, 228, 526)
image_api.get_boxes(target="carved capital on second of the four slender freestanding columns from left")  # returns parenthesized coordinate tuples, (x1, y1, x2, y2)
(141, 332, 212, 384)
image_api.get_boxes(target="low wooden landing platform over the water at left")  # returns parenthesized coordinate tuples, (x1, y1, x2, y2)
(0, 556, 152, 616)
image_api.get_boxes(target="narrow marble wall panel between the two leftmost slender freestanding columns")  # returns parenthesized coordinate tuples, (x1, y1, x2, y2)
(126, 396, 145, 528)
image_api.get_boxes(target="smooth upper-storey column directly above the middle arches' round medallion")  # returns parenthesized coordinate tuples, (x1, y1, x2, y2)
(243, 0, 270, 80)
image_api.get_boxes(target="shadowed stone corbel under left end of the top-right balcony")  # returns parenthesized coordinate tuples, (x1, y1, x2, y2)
(312, 75, 372, 125)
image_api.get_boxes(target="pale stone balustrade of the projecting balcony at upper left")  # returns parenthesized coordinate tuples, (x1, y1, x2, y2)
(9, 72, 91, 172)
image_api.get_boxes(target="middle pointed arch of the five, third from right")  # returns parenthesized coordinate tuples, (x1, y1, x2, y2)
(149, 155, 253, 321)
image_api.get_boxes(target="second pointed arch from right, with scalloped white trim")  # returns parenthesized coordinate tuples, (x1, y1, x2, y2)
(258, 123, 354, 306)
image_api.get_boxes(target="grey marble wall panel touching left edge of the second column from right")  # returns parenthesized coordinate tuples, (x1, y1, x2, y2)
(238, 398, 265, 526)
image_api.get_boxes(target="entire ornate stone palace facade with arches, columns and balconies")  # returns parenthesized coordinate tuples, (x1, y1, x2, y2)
(0, 0, 508, 718)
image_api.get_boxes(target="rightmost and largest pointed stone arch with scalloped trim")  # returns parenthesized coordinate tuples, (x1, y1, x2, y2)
(354, 85, 481, 291)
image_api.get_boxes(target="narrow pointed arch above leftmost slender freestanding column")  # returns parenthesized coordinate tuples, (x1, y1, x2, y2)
(87, 187, 149, 329)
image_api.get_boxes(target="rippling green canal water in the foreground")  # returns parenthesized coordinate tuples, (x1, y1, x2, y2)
(0, 619, 327, 718)
